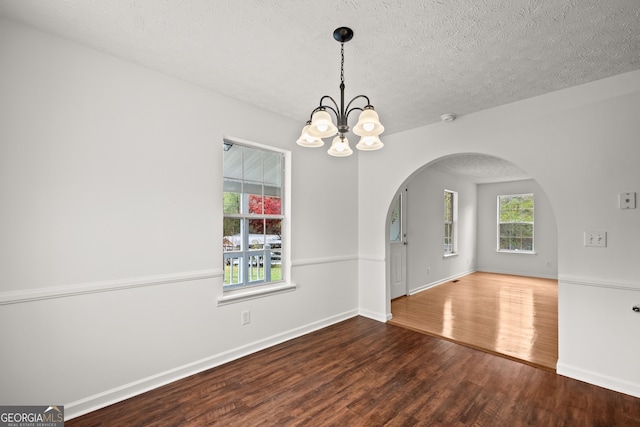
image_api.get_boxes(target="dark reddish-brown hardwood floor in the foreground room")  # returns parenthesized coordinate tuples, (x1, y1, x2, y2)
(65, 317, 640, 427)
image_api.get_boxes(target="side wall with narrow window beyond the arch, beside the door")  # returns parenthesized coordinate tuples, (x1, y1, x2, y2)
(407, 167, 477, 294)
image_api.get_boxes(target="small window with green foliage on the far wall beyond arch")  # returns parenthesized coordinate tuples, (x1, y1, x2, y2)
(498, 194, 534, 253)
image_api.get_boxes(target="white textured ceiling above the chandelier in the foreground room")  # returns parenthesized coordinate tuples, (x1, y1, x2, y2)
(0, 0, 640, 136)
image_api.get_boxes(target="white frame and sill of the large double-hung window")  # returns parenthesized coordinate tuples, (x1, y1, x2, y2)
(218, 136, 296, 305)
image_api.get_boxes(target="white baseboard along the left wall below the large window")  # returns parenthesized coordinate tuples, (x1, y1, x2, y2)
(64, 310, 358, 421)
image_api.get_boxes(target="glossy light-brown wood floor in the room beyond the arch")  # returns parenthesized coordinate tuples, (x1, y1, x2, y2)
(389, 273, 558, 372)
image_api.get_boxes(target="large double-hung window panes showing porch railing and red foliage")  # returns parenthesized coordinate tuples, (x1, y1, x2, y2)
(223, 140, 287, 291)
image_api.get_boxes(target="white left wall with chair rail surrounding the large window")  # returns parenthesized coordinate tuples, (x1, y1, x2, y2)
(0, 20, 358, 417)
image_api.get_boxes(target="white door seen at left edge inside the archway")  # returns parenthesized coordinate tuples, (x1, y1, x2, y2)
(389, 189, 407, 299)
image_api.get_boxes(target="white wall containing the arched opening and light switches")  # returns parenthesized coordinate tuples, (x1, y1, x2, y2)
(358, 71, 640, 396)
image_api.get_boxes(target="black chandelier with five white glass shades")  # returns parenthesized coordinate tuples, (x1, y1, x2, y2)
(296, 27, 384, 157)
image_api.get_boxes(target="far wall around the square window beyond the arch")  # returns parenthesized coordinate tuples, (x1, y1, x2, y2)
(478, 180, 558, 279)
